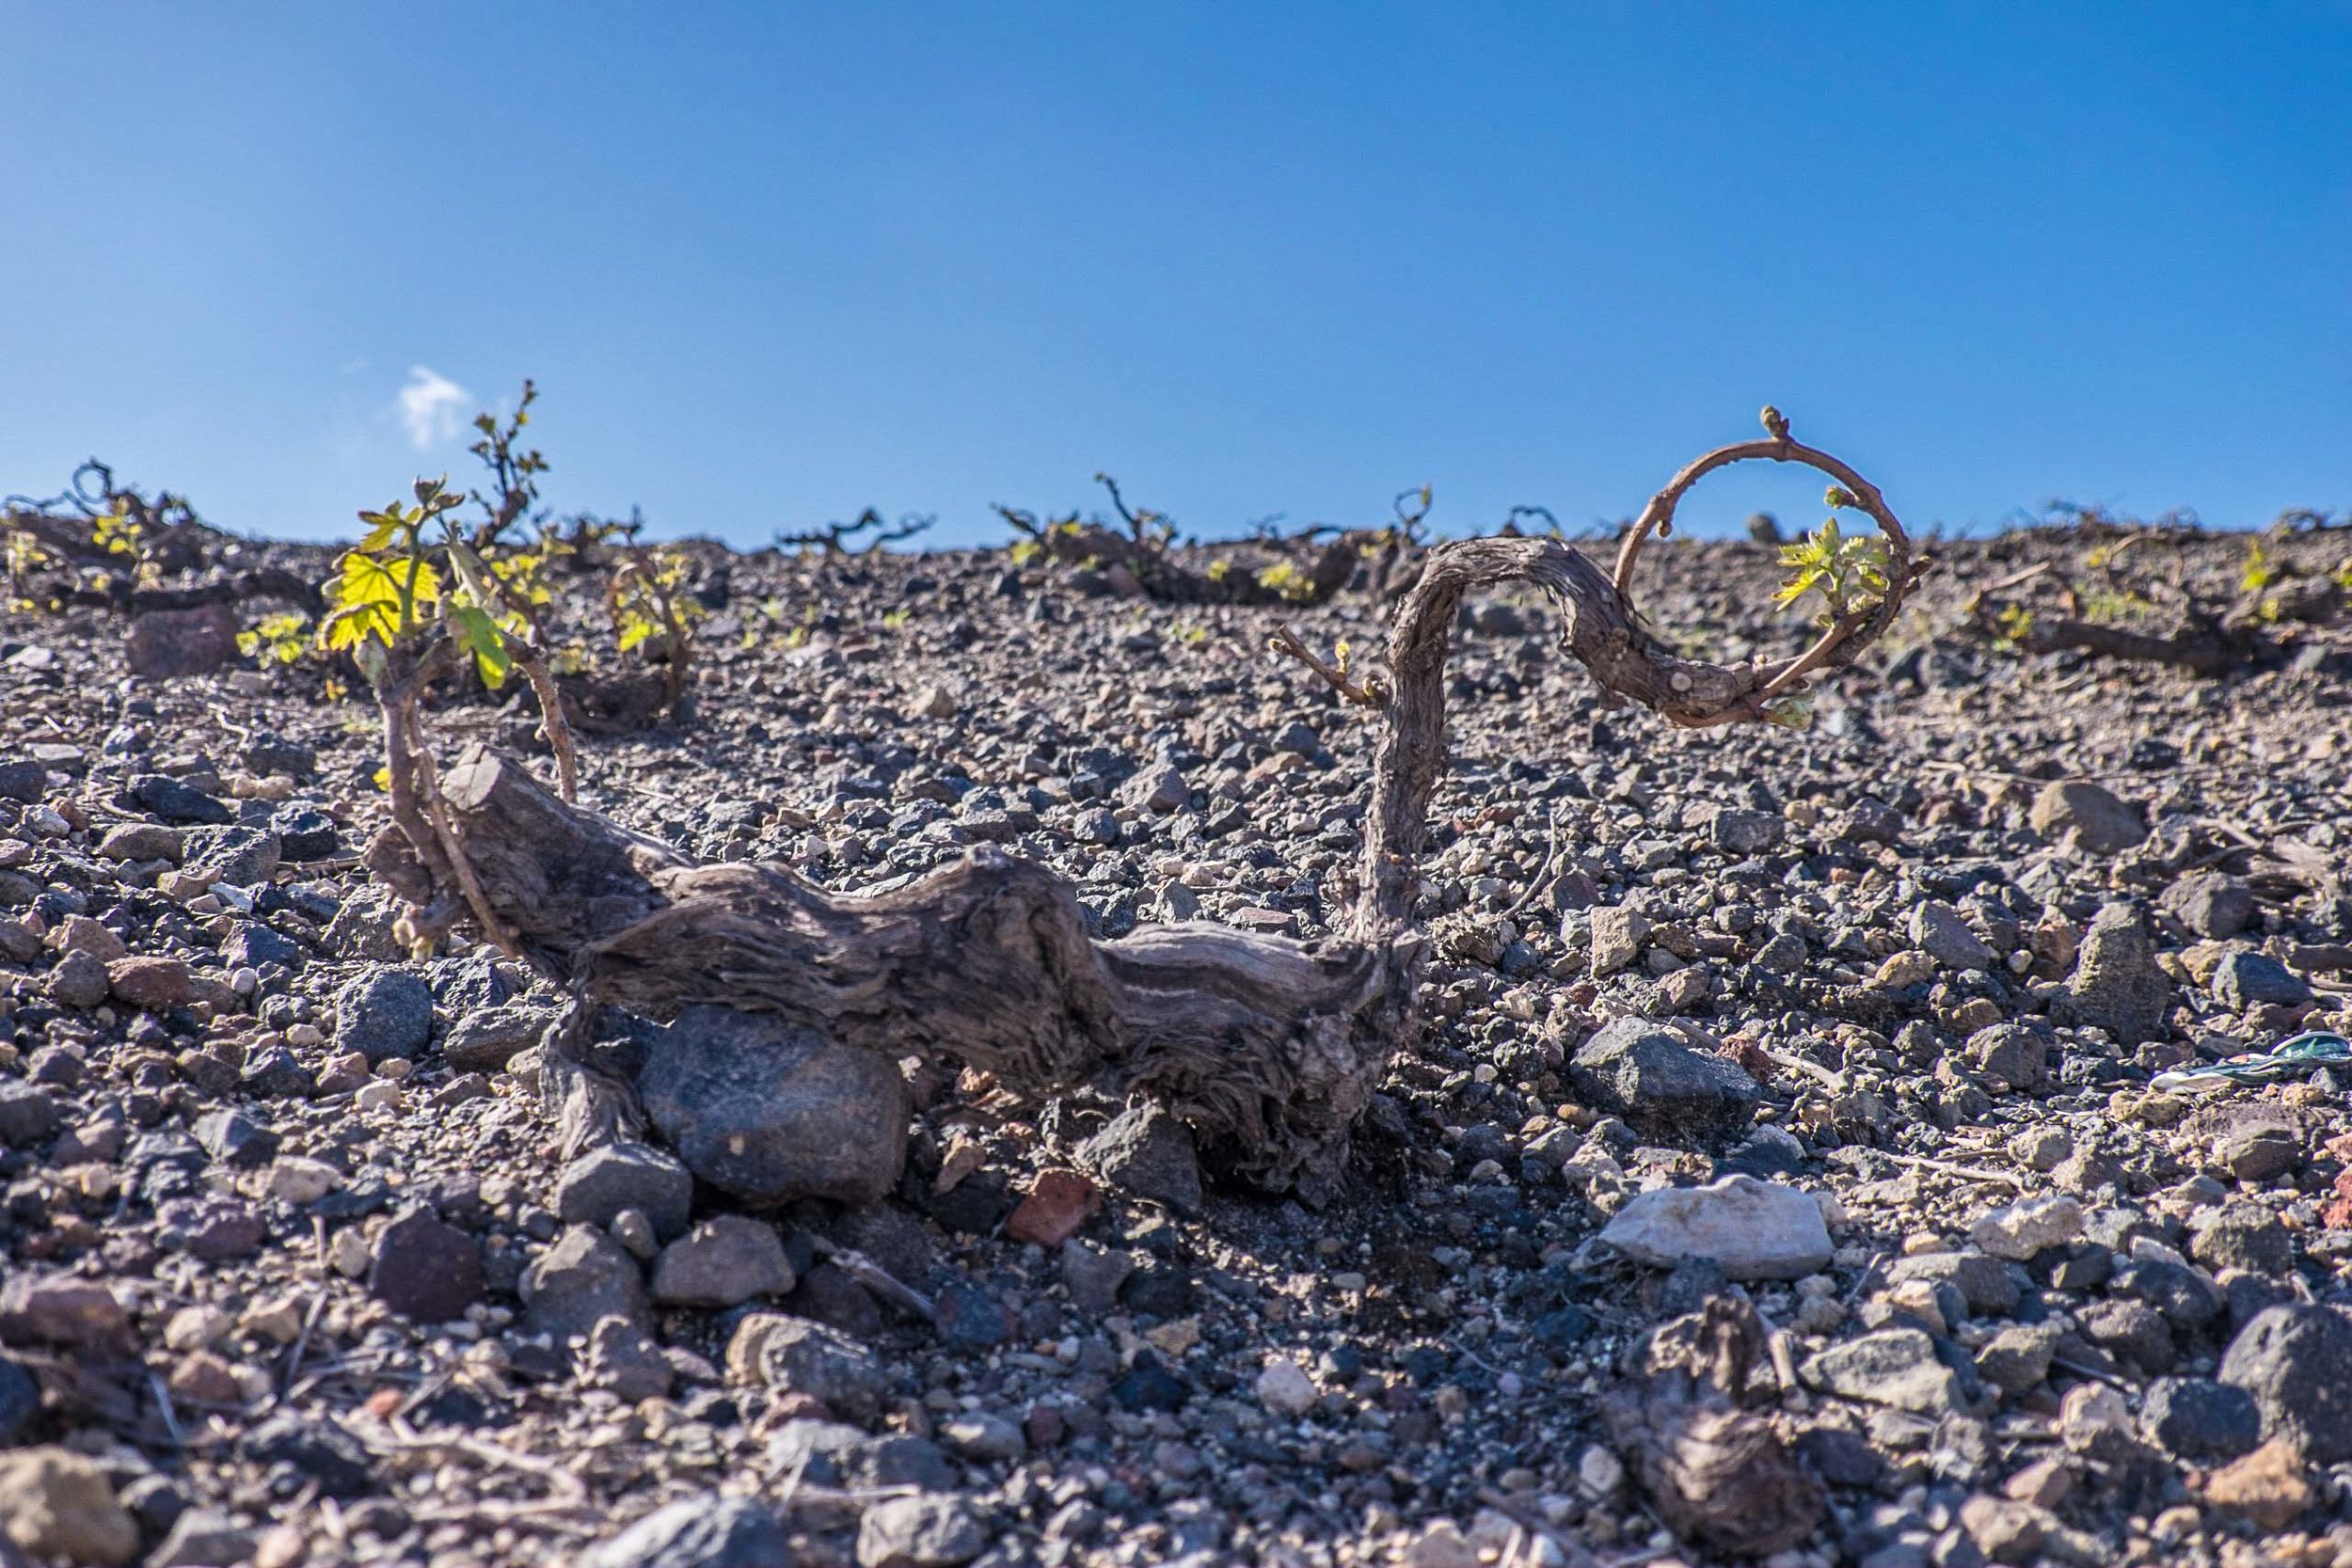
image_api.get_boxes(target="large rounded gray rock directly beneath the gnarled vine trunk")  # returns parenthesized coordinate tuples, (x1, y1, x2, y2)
(638, 1006, 911, 1204)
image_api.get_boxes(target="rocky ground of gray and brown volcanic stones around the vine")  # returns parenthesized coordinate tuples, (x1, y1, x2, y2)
(0, 531, 2352, 1568)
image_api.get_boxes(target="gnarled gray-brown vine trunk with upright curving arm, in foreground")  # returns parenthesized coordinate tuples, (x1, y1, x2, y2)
(370, 430, 1910, 1199)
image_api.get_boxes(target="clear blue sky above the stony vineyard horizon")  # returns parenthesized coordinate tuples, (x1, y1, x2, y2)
(0, 0, 2352, 543)
